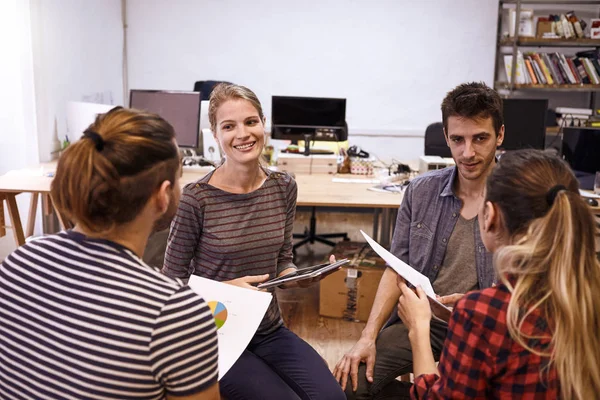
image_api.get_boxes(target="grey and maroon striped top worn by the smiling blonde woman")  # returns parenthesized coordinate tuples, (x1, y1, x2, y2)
(163, 169, 298, 334)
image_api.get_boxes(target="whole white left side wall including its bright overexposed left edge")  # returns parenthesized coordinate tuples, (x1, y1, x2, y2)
(0, 0, 123, 260)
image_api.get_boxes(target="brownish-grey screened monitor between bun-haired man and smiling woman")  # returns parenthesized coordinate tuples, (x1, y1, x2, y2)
(129, 89, 202, 149)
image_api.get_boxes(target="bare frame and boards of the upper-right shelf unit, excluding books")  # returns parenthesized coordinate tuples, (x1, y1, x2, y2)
(494, 0, 600, 97)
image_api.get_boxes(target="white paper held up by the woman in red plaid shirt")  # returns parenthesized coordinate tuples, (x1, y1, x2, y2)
(360, 230, 452, 322)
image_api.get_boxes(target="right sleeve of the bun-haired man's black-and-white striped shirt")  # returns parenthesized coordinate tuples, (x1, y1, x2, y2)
(150, 286, 218, 396)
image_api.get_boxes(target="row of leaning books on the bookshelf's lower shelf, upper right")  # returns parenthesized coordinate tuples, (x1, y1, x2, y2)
(504, 50, 600, 85)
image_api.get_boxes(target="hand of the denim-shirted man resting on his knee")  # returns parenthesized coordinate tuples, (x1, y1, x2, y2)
(333, 338, 376, 392)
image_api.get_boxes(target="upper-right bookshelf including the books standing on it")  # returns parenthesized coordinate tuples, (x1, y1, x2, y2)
(494, 0, 600, 95)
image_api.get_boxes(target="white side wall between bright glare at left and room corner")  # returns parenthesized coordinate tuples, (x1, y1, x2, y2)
(30, 0, 123, 161)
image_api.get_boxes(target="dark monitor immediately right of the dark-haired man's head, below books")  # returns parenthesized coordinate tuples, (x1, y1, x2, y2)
(500, 99, 548, 150)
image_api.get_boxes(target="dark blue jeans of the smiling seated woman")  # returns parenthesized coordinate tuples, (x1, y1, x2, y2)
(219, 326, 346, 400)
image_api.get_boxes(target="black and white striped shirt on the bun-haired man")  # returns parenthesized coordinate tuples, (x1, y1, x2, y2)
(0, 231, 218, 399)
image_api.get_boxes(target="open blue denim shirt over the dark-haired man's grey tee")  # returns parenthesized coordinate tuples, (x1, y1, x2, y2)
(391, 167, 496, 289)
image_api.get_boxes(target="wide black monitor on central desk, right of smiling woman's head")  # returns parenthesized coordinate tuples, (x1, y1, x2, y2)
(271, 96, 348, 142)
